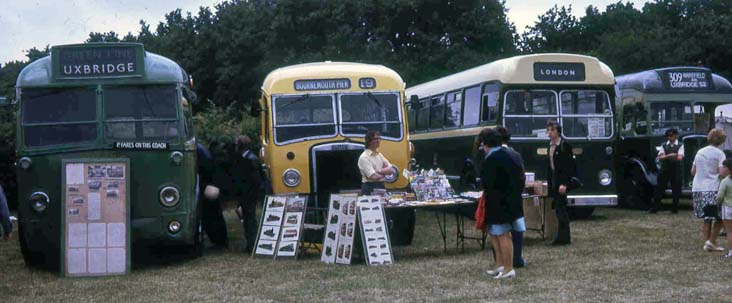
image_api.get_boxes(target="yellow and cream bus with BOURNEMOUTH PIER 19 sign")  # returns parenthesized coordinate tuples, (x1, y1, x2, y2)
(254, 61, 410, 205)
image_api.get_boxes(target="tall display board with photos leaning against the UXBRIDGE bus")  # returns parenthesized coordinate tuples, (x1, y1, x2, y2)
(61, 159, 130, 277)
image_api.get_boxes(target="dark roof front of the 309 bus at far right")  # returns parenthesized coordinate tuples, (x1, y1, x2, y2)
(616, 66, 732, 93)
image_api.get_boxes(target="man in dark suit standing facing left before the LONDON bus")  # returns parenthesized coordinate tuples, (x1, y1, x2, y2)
(546, 120, 577, 245)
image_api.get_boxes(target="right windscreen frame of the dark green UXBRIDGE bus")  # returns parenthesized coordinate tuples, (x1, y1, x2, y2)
(98, 83, 182, 143)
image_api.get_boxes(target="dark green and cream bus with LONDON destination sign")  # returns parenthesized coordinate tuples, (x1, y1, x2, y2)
(407, 53, 617, 217)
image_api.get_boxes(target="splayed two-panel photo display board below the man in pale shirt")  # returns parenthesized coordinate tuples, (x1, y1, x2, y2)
(320, 195, 394, 265)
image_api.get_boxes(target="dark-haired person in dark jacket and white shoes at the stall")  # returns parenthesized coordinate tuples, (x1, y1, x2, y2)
(479, 128, 523, 279)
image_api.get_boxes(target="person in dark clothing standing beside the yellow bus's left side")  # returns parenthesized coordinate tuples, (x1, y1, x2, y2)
(232, 135, 264, 253)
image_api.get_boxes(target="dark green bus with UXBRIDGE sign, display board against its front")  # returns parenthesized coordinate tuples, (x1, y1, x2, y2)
(15, 43, 202, 269)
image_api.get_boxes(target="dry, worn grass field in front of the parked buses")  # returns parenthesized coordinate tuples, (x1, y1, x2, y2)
(0, 202, 732, 302)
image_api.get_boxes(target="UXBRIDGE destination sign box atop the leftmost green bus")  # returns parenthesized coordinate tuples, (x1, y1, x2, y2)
(51, 43, 144, 79)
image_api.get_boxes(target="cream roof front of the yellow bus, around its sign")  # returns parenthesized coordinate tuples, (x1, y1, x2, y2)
(262, 61, 405, 94)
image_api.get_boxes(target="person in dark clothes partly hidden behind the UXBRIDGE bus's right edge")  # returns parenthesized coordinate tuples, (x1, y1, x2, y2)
(196, 143, 229, 249)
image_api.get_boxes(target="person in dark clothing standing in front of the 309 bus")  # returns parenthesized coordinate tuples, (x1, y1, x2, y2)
(648, 128, 684, 214)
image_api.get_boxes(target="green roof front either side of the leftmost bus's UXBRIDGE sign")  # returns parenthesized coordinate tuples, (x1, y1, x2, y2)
(15, 47, 188, 87)
